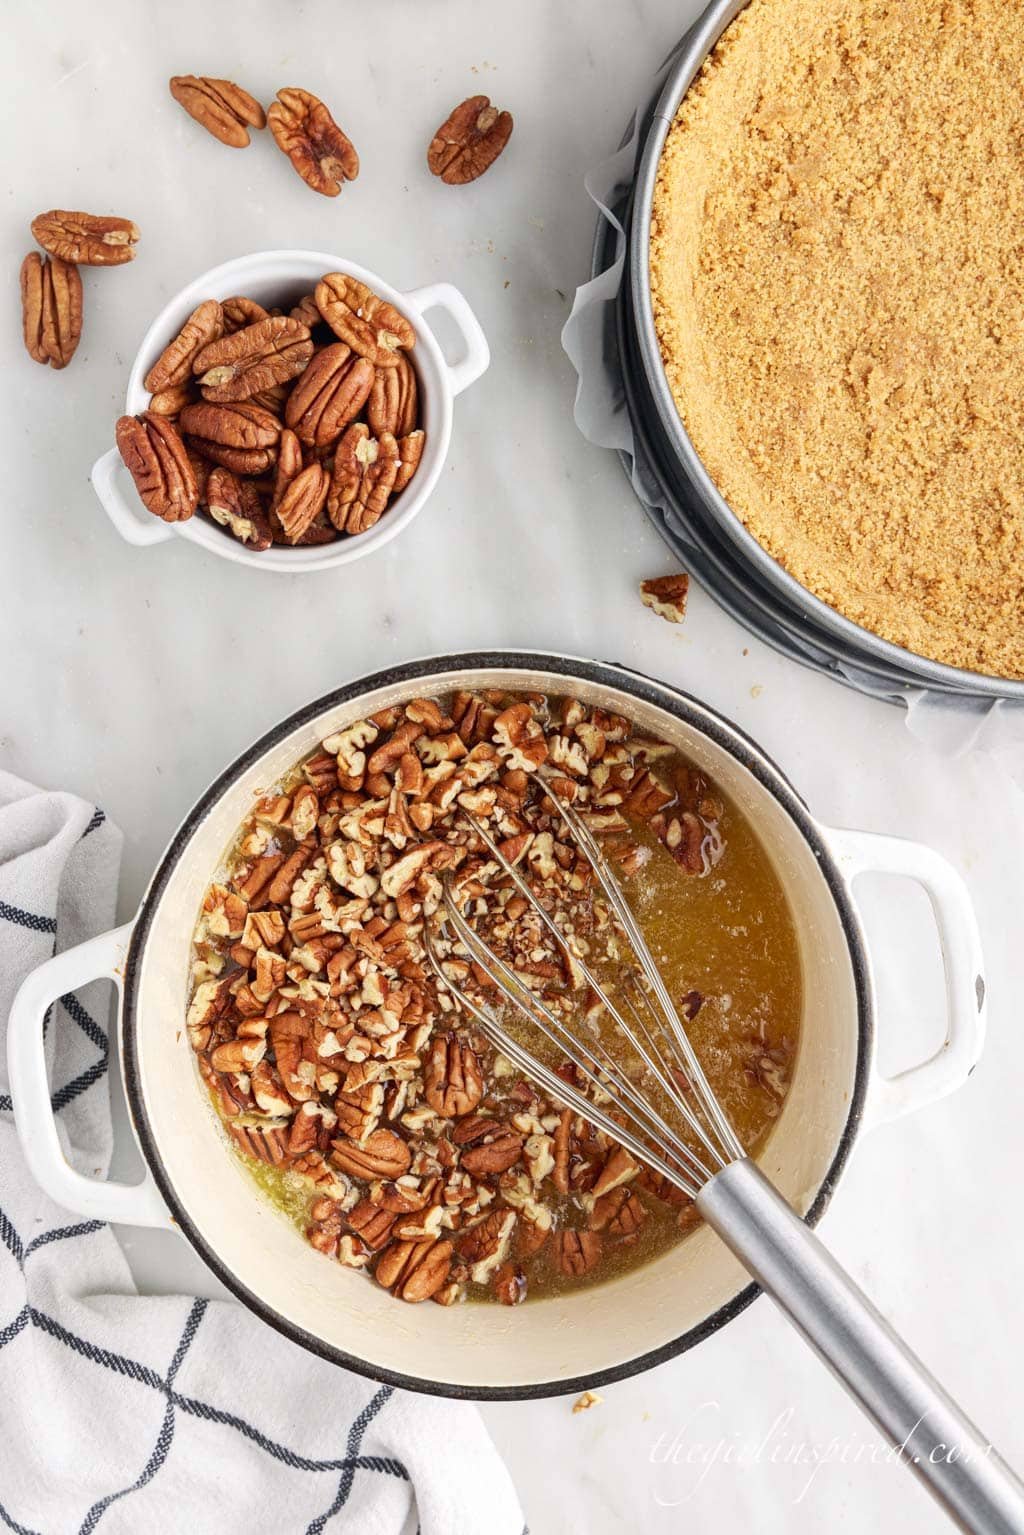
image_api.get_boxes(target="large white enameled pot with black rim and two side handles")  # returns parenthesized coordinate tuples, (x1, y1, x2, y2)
(9, 652, 984, 1398)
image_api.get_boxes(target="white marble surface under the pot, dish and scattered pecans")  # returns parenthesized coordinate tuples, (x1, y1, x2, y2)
(0, 0, 1024, 1535)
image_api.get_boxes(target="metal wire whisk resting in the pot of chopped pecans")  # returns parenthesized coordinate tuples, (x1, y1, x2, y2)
(427, 774, 1024, 1535)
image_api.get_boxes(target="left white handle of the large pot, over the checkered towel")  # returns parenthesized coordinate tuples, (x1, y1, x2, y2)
(8, 923, 173, 1228)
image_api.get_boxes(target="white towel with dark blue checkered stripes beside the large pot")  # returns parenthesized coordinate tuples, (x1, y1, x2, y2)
(0, 772, 524, 1535)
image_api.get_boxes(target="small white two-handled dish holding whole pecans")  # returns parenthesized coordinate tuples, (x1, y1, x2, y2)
(92, 250, 491, 574)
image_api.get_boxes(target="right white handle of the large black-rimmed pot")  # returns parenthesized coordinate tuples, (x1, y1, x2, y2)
(826, 827, 986, 1127)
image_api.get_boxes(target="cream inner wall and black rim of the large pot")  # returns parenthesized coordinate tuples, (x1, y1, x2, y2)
(125, 668, 858, 1392)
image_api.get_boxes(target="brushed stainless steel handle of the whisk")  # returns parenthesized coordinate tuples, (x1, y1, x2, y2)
(706, 1157, 1024, 1535)
